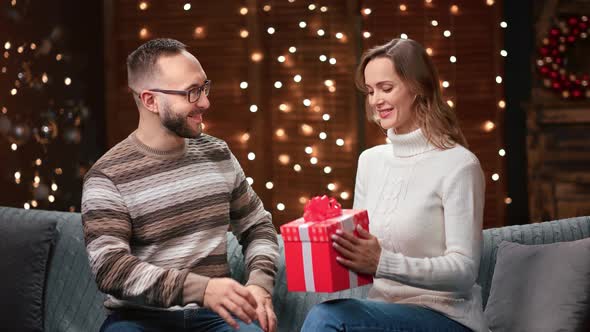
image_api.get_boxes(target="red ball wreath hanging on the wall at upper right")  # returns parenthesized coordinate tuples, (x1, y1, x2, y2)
(537, 16, 590, 99)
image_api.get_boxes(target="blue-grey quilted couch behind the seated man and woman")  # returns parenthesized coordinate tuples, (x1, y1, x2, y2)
(0, 207, 590, 332)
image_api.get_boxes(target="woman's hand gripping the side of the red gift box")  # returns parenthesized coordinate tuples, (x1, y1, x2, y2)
(332, 226, 381, 275)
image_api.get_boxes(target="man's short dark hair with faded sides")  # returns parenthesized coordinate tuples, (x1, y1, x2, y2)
(127, 38, 186, 88)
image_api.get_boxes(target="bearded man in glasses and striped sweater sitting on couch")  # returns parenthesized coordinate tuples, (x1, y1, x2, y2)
(82, 39, 278, 331)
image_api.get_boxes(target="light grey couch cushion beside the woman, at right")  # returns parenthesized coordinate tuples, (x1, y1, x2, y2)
(485, 238, 590, 331)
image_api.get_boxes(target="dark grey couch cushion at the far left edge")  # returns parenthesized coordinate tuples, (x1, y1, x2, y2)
(0, 214, 56, 331)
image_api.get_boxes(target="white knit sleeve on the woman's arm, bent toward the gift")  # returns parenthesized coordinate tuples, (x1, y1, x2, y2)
(376, 161, 485, 291)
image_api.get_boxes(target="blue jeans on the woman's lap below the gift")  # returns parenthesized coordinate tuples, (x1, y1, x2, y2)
(301, 299, 471, 332)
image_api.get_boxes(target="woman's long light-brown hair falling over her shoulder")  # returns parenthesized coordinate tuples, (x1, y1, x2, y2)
(355, 38, 467, 150)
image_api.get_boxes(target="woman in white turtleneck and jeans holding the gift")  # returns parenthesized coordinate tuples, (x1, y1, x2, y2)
(302, 39, 487, 331)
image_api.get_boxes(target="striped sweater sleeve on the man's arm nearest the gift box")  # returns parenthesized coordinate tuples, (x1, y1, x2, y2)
(230, 152, 279, 294)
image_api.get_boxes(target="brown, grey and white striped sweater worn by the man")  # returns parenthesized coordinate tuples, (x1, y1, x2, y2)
(82, 133, 279, 310)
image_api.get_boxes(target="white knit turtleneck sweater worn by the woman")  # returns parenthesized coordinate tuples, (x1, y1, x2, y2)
(354, 129, 487, 331)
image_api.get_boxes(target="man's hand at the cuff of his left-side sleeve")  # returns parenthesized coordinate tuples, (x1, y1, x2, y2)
(203, 278, 258, 329)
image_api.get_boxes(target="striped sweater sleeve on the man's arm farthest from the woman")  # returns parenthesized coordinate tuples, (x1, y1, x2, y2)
(82, 170, 192, 307)
